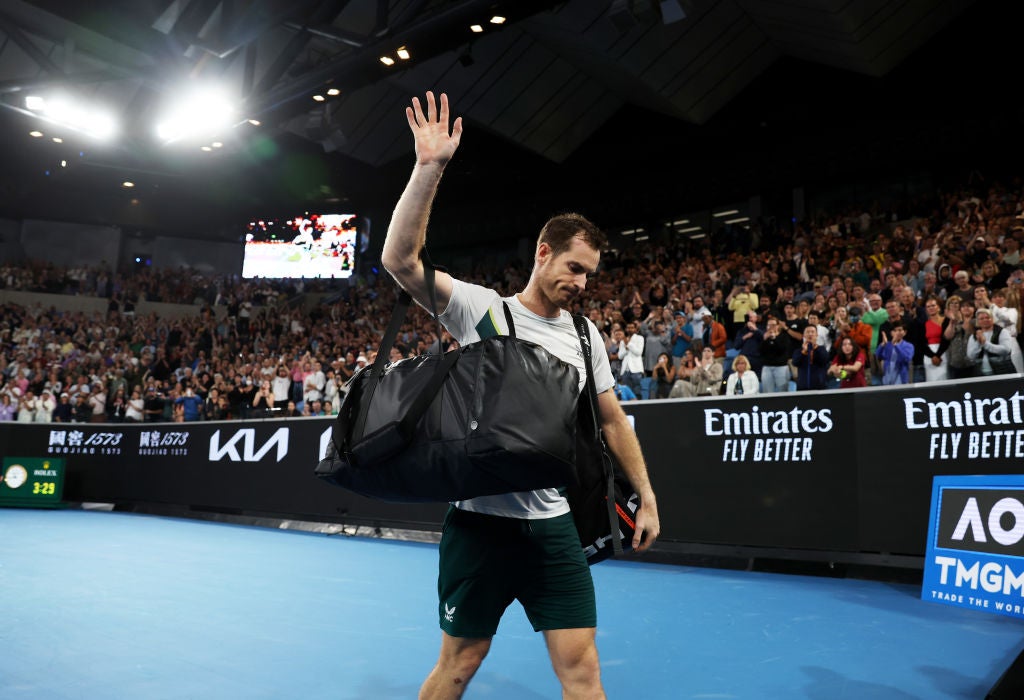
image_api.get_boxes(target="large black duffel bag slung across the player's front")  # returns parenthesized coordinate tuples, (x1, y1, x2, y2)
(315, 261, 580, 502)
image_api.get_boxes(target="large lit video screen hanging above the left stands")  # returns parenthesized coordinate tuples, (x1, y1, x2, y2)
(242, 214, 367, 279)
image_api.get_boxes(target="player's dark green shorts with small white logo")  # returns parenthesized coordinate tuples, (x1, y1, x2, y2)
(437, 507, 597, 637)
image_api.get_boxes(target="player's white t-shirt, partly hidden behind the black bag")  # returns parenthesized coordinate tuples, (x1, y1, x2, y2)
(440, 279, 615, 520)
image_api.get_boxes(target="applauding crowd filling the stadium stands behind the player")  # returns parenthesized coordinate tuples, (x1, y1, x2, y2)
(0, 182, 1024, 423)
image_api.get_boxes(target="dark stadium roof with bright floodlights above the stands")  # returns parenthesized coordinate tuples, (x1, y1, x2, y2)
(0, 0, 1020, 241)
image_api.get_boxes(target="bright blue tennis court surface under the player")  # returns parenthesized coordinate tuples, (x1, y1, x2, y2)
(0, 510, 1024, 700)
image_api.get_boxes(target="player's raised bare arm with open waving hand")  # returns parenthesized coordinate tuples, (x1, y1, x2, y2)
(381, 92, 462, 313)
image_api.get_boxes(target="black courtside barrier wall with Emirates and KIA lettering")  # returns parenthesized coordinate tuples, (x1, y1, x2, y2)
(0, 377, 1024, 557)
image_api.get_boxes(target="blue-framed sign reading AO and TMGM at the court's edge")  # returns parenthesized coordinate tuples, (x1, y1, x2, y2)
(921, 475, 1024, 619)
